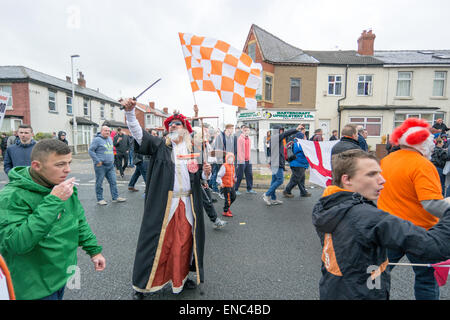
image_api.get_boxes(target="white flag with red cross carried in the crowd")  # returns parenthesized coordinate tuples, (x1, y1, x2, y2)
(298, 140, 338, 188)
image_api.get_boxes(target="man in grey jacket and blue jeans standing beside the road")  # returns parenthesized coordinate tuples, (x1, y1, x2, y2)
(89, 126, 126, 205)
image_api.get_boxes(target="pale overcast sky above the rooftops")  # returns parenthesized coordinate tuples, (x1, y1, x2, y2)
(0, 0, 450, 126)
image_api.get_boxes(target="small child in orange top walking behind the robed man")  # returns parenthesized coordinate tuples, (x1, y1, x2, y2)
(216, 152, 236, 217)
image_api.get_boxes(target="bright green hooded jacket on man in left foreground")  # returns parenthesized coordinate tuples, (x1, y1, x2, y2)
(0, 167, 102, 300)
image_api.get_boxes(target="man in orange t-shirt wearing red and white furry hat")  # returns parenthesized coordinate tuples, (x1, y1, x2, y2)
(377, 118, 450, 300)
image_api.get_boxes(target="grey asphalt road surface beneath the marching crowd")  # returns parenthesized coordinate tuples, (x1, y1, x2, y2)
(0, 154, 450, 302)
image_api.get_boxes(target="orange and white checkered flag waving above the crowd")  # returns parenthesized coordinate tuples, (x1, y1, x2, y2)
(179, 33, 262, 110)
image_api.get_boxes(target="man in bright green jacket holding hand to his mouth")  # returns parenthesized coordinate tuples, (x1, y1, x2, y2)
(0, 139, 105, 300)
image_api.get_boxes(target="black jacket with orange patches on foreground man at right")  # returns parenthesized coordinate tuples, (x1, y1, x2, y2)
(312, 186, 450, 300)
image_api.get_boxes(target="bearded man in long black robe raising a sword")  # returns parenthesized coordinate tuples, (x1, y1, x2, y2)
(122, 99, 211, 299)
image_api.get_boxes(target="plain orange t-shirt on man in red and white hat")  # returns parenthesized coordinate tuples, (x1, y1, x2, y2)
(377, 150, 443, 230)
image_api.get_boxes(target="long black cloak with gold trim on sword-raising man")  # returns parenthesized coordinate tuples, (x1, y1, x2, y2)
(133, 130, 205, 292)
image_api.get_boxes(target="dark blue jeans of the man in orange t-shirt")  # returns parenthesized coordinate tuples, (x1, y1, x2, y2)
(387, 249, 439, 300)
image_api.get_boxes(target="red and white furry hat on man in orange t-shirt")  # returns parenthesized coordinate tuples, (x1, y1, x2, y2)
(390, 118, 434, 159)
